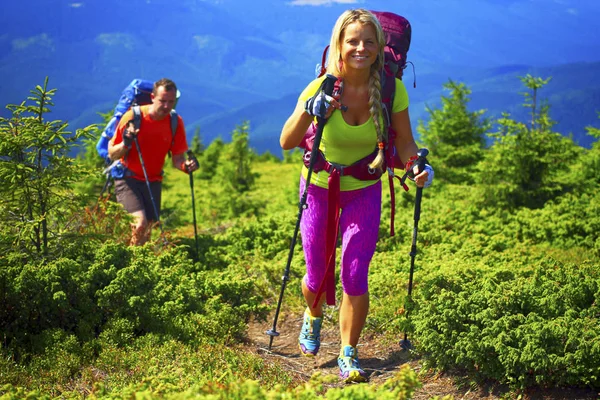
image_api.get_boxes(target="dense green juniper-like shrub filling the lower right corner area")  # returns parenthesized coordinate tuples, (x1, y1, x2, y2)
(413, 260, 600, 388)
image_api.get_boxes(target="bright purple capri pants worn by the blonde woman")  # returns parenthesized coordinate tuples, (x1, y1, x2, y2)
(300, 176, 381, 296)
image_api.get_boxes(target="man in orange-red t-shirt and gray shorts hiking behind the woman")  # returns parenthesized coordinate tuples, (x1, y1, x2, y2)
(108, 78, 198, 245)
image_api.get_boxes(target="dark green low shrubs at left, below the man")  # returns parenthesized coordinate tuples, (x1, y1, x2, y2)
(0, 241, 266, 368)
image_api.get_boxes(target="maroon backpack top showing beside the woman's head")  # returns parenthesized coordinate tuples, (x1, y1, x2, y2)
(371, 11, 412, 79)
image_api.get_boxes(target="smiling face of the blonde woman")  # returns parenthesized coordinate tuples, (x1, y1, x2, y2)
(340, 21, 379, 70)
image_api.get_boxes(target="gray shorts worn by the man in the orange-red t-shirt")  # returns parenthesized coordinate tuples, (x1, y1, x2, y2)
(115, 178, 162, 221)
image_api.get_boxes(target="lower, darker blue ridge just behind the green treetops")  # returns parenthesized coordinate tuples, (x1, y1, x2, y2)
(196, 62, 600, 155)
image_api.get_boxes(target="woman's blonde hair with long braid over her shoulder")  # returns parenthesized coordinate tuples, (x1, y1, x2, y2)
(327, 8, 388, 169)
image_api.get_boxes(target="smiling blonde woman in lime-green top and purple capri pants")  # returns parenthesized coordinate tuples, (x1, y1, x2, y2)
(280, 9, 433, 382)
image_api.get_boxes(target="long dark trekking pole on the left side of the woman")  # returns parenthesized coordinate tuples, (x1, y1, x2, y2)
(265, 74, 337, 350)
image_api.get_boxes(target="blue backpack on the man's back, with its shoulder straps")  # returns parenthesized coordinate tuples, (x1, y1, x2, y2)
(96, 79, 179, 179)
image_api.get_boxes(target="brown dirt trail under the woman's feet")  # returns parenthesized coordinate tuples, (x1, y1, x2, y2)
(247, 312, 600, 400)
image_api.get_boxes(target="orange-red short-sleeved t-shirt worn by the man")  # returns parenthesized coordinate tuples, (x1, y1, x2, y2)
(111, 105, 188, 182)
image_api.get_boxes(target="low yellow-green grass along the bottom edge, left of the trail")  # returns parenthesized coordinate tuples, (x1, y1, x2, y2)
(0, 352, 422, 400)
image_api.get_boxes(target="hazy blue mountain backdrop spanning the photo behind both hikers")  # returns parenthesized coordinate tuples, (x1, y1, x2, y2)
(0, 0, 600, 154)
